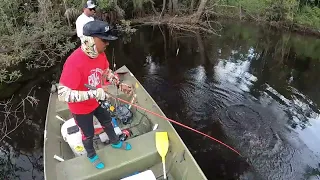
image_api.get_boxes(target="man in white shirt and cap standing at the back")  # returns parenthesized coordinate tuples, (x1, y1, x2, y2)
(76, 0, 96, 42)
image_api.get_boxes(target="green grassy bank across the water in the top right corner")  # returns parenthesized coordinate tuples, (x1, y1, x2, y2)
(209, 0, 320, 35)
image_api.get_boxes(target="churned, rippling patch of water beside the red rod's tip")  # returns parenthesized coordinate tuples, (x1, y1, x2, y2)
(219, 105, 304, 180)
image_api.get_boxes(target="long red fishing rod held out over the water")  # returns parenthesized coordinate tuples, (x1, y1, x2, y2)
(85, 84, 242, 157)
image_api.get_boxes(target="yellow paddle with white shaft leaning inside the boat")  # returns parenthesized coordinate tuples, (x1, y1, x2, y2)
(156, 132, 169, 179)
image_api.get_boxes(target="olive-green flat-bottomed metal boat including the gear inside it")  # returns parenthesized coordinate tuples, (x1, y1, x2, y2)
(44, 66, 207, 180)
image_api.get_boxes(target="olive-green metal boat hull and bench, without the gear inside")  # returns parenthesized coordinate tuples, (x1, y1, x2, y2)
(44, 66, 207, 180)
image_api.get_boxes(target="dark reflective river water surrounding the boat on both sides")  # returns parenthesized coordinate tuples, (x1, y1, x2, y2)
(0, 23, 320, 180)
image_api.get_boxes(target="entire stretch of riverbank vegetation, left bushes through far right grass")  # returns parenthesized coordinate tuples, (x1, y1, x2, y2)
(0, 0, 320, 83)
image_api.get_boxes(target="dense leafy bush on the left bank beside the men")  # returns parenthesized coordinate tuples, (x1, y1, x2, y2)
(0, 0, 75, 83)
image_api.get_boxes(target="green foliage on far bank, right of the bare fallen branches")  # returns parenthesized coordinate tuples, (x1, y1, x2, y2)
(212, 0, 320, 28)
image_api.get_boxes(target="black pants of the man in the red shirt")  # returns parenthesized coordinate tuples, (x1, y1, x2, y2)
(73, 106, 119, 158)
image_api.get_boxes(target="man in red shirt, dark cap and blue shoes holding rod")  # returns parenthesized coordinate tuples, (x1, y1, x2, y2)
(58, 20, 132, 169)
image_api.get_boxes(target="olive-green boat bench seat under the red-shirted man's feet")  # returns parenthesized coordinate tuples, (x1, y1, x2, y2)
(56, 131, 161, 180)
